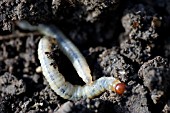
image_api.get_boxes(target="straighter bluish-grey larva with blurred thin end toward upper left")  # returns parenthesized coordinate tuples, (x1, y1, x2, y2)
(17, 21, 92, 84)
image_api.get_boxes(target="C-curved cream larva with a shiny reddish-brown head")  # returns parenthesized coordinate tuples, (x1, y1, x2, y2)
(38, 37, 125, 100)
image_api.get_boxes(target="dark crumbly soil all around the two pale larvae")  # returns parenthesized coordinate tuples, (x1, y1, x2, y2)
(0, 0, 170, 113)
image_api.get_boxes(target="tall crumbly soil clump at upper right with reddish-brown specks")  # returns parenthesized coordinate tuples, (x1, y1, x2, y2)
(120, 4, 161, 64)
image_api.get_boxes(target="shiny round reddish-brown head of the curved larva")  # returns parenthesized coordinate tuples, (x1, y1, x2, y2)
(114, 83, 126, 95)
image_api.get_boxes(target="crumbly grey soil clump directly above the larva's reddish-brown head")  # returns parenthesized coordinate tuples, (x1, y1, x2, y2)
(98, 47, 134, 82)
